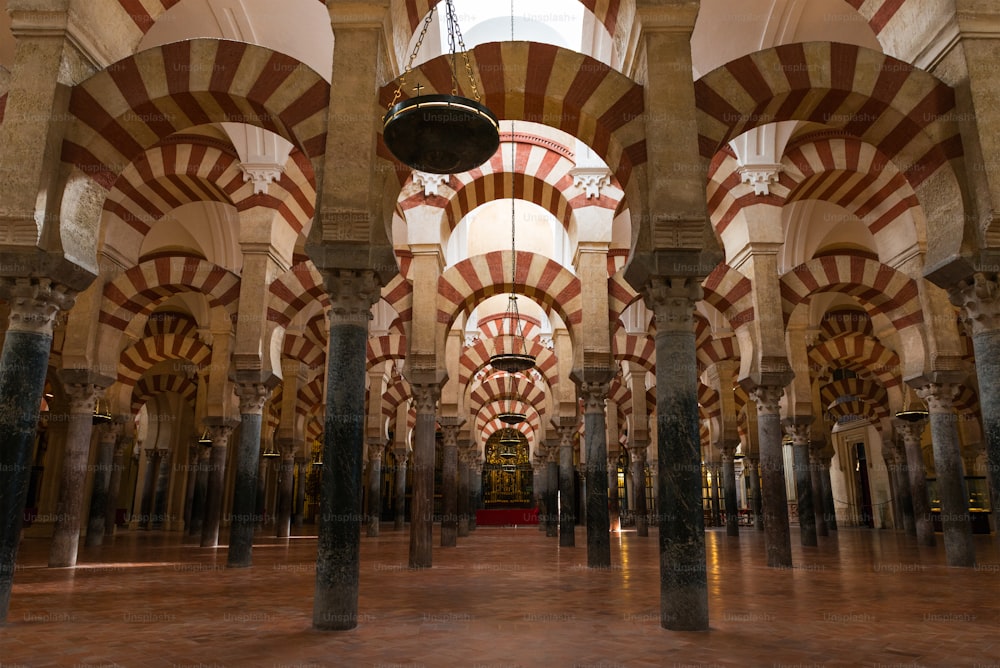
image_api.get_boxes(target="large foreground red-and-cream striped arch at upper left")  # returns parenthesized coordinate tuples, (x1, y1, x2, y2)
(62, 39, 330, 188)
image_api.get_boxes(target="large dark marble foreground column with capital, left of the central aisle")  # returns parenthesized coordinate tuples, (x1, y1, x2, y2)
(313, 270, 380, 631)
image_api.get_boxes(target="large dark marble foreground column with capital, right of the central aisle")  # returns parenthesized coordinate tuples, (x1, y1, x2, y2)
(643, 278, 708, 631)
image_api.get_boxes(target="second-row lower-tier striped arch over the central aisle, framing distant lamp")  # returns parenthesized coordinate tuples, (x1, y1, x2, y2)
(437, 251, 583, 340)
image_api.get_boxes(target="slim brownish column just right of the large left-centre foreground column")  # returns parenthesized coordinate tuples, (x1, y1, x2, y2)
(409, 382, 441, 568)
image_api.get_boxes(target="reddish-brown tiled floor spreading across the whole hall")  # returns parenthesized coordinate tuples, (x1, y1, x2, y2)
(0, 527, 1000, 668)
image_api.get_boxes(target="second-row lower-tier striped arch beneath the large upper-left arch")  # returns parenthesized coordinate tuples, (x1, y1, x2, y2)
(99, 257, 240, 331)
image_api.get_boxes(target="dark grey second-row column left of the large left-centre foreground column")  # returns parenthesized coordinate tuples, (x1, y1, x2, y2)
(226, 381, 271, 568)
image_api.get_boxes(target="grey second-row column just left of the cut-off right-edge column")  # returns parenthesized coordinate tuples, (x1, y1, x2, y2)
(917, 383, 976, 568)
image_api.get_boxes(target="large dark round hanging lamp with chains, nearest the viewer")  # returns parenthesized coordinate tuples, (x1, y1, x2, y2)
(382, 0, 500, 174)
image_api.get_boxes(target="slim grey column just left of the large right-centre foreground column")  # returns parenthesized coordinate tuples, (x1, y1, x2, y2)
(578, 380, 614, 568)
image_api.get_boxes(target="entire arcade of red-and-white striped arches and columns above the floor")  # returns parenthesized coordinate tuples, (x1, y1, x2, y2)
(0, 0, 1000, 664)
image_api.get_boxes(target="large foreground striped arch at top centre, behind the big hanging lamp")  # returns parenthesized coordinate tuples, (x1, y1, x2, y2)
(378, 42, 646, 192)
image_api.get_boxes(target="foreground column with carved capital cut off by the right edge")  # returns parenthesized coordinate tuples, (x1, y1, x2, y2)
(949, 273, 1000, 541)
